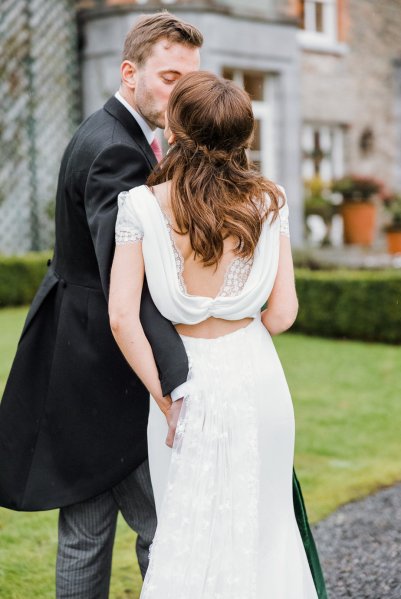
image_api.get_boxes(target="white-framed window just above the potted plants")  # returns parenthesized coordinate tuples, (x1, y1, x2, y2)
(302, 123, 345, 182)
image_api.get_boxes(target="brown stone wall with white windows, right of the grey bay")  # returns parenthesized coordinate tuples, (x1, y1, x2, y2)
(292, 0, 401, 191)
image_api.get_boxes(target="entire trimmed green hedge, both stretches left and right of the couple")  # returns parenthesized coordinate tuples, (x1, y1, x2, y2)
(0, 252, 401, 343)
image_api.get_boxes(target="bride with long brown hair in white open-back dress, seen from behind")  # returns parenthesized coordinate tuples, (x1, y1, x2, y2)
(109, 72, 326, 599)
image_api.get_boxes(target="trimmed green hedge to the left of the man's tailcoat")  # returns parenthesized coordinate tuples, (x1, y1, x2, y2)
(0, 252, 51, 307)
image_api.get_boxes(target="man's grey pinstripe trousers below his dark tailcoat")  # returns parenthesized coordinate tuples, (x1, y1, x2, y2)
(56, 460, 157, 599)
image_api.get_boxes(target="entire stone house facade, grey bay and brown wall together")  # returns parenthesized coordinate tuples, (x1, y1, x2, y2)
(80, 0, 401, 245)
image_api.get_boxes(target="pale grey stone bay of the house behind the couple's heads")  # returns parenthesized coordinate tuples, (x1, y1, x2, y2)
(80, 0, 303, 245)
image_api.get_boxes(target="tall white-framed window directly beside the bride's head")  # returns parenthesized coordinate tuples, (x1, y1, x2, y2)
(222, 67, 276, 179)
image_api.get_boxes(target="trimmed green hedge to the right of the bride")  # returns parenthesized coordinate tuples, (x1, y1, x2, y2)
(292, 269, 401, 343)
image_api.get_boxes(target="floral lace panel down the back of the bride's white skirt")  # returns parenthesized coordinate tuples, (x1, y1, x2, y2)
(141, 329, 260, 599)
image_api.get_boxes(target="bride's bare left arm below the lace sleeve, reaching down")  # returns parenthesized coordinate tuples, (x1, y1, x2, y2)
(109, 241, 171, 416)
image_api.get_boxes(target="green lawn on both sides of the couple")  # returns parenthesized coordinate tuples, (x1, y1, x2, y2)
(0, 308, 401, 599)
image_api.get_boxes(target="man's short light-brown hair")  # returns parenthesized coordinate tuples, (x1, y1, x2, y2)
(123, 11, 203, 66)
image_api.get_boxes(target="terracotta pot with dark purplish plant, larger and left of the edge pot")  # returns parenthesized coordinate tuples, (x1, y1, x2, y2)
(332, 175, 384, 246)
